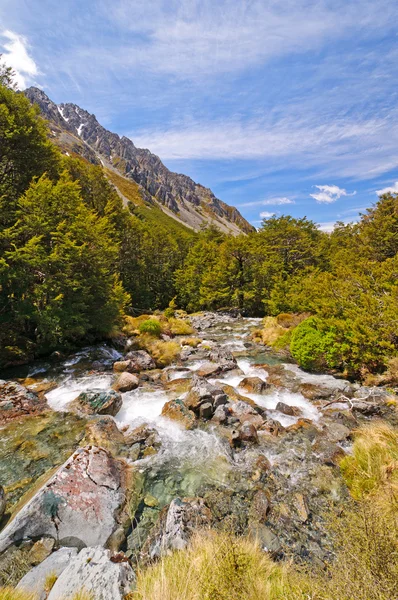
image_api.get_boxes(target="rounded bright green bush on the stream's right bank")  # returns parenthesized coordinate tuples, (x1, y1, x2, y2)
(290, 317, 339, 370)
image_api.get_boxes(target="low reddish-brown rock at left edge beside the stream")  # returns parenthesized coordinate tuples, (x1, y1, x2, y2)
(0, 380, 49, 425)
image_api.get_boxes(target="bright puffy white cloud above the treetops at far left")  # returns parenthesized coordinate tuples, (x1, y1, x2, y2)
(1, 30, 39, 90)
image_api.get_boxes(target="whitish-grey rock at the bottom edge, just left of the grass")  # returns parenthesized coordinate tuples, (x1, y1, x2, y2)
(48, 547, 135, 600)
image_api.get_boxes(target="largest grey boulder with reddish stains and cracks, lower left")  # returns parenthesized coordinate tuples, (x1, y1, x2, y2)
(0, 446, 125, 553)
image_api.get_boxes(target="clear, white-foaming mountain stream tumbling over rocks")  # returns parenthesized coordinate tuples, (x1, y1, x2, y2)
(0, 314, 392, 565)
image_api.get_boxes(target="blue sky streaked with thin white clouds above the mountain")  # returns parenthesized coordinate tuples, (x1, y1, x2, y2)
(0, 0, 398, 231)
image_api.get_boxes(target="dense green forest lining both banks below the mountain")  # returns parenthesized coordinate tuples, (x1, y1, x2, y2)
(0, 67, 398, 379)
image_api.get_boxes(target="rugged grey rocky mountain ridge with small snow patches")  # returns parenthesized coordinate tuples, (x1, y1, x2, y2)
(24, 87, 254, 235)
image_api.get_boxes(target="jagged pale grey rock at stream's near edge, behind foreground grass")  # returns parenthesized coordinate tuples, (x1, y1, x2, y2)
(142, 498, 212, 560)
